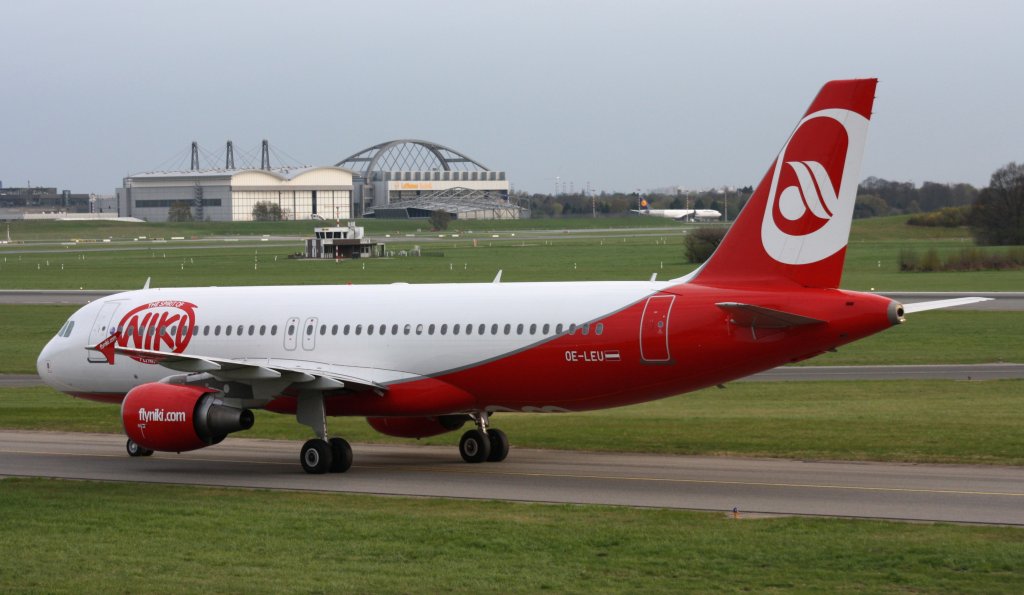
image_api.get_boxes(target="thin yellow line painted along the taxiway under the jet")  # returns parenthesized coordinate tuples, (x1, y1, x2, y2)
(0, 450, 1024, 498)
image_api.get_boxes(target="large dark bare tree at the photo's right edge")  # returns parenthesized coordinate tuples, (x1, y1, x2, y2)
(971, 163, 1024, 246)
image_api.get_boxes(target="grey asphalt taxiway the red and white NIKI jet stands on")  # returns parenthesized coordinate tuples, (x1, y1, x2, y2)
(0, 430, 1024, 525)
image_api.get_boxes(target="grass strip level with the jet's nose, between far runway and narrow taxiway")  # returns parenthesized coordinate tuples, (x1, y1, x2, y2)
(0, 305, 1024, 374)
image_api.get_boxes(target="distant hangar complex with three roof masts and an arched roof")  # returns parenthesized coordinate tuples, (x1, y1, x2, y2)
(117, 139, 529, 221)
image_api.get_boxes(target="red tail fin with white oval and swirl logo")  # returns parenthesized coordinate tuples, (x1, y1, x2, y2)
(692, 79, 878, 288)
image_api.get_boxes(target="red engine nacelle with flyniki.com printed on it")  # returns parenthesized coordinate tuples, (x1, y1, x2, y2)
(121, 382, 253, 453)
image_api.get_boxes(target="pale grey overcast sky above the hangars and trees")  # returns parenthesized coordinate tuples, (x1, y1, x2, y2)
(0, 0, 1024, 194)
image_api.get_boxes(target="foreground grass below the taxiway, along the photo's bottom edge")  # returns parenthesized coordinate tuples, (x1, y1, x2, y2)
(0, 479, 1024, 593)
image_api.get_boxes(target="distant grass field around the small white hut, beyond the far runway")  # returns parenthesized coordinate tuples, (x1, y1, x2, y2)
(6, 217, 1024, 291)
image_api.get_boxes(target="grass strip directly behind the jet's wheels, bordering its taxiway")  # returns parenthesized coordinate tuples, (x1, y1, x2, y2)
(0, 380, 1024, 465)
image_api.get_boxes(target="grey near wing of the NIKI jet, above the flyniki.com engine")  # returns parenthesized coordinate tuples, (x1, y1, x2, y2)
(114, 346, 387, 391)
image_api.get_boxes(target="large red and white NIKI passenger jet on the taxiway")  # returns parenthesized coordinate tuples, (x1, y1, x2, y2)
(37, 79, 986, 473)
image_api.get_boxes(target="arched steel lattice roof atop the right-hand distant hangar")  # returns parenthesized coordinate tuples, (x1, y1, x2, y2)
(335, 138, 490, 172)
